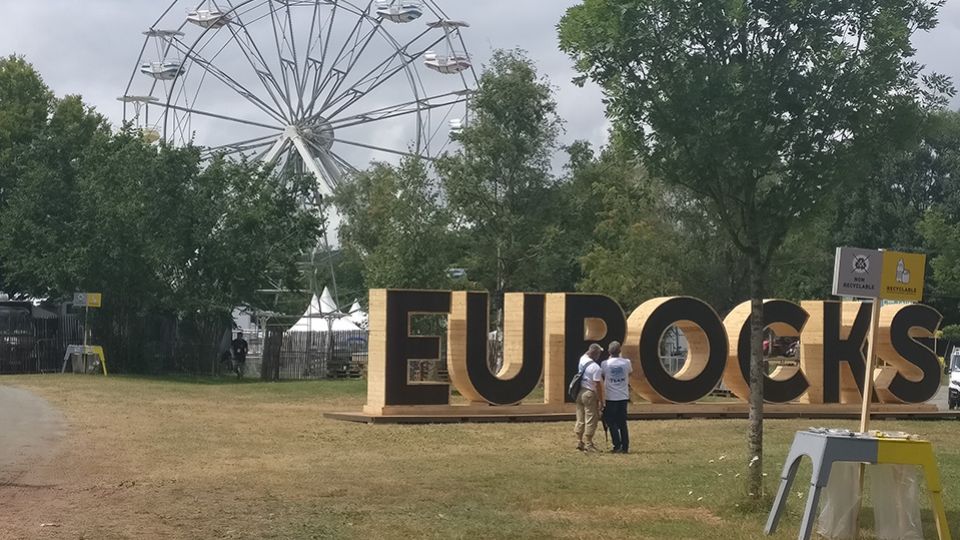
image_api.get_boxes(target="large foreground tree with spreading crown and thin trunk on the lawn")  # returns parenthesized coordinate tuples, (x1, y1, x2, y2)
(559, 0, 949, 497)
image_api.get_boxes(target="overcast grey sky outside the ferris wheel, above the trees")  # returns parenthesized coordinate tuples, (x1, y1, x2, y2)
(0, 0, 960, 169)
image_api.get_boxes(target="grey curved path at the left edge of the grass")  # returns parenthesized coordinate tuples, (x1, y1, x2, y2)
(0, 386, 65, 487)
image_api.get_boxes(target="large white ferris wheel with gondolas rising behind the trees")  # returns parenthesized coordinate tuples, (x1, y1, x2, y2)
(119, 0, 477, 195)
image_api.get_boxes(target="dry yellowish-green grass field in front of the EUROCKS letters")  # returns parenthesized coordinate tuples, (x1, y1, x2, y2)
(0, 375, 960, 540)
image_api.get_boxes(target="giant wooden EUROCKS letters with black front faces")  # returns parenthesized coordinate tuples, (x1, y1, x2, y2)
(364, 289, 941, 416)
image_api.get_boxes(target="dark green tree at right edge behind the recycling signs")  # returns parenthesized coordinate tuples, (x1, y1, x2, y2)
(770, 110, 960, 320)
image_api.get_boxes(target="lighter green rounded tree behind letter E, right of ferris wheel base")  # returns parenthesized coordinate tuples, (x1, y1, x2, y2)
(333, 158, 455, 289)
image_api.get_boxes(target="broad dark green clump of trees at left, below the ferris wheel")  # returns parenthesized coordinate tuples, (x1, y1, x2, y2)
(0, 97, 321, 371)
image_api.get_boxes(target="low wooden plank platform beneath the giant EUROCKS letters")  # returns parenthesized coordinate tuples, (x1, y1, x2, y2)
(323, 403, 960, 424)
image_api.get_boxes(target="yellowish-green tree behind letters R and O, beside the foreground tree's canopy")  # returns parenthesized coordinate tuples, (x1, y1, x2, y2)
(564, 140, 746, 312)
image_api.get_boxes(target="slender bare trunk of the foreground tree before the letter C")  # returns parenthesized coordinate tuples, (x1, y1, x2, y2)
(747, 253, 766, 499)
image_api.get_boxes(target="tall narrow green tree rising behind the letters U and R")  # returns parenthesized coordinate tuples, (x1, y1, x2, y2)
(436, 51, 577, 321)
